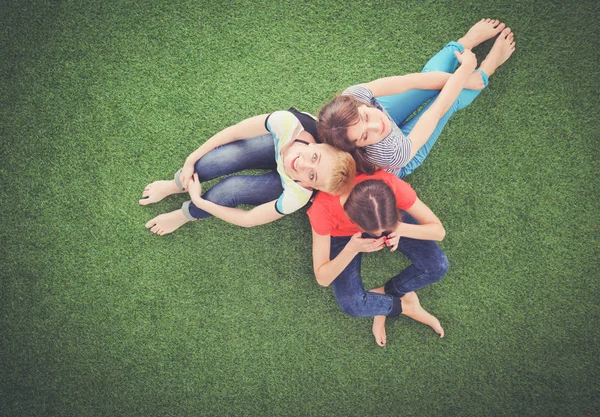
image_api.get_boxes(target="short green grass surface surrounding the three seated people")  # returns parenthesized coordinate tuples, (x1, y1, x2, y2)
(0, 0, 600, 416)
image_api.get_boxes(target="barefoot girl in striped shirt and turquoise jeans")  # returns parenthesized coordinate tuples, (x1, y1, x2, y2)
(318, 19, 515, 178)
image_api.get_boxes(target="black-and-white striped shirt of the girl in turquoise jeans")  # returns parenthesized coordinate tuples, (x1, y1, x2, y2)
(342, 85, 412, 175)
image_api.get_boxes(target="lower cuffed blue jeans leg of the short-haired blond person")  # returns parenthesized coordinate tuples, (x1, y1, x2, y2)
(181, 172, 283, 220)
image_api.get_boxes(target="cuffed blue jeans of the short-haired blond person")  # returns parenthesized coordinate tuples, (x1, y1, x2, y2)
(175, 134, 283, 220)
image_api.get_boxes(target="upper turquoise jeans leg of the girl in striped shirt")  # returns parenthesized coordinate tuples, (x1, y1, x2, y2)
(377, 42, 464, 125)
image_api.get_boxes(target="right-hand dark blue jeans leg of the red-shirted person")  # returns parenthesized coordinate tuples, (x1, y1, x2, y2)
(385, 212, 449, 297)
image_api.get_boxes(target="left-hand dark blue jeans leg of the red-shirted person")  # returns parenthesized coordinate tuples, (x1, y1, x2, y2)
(330, 237, 402, 317)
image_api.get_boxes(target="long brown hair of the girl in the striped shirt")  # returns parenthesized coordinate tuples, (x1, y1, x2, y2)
(317, 96, 379, 174)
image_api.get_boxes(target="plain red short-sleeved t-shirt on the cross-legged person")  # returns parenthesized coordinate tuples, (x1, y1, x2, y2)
(308, 170, 417, 236)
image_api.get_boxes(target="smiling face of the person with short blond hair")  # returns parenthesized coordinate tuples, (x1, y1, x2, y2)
(283, 142, 334, 190)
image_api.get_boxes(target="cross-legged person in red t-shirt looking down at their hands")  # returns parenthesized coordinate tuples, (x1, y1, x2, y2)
(308, 171, 448, 346)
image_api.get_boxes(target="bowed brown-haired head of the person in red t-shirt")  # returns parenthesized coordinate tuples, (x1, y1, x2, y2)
(344, 180, 400, 233)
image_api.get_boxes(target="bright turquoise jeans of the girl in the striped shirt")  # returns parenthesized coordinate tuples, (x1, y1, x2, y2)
(377, 42, 488, 178)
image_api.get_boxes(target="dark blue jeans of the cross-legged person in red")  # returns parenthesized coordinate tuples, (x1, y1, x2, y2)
(330, 212, 449, 317)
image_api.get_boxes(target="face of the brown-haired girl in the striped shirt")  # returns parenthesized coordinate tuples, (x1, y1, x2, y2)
(348, 105, 391, 148)
